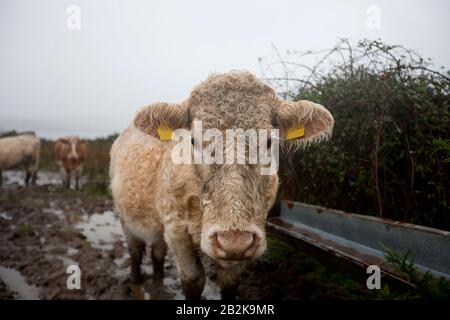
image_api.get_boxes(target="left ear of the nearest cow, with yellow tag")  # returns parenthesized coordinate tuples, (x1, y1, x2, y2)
(133, 102, 189, 140)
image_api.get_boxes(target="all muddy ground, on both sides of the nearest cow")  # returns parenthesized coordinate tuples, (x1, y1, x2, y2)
(0, 171, 434, 299)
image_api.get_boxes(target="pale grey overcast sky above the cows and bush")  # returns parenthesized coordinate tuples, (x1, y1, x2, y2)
(0, 0, 450, 138)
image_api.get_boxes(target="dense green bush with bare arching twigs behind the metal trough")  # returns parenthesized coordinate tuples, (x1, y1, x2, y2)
(277, 40, 450, 230)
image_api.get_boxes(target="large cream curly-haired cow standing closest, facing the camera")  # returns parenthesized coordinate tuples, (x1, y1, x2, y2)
(110, 71, 334, 299)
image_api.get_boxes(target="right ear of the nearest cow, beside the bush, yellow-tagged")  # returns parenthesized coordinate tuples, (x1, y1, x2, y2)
(275, 100, 334, 149)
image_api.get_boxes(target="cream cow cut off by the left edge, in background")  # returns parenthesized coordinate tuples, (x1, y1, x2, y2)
(0, 133, 41, 185)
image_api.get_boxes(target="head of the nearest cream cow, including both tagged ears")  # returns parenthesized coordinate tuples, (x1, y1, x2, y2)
(134, 72, 334, 260)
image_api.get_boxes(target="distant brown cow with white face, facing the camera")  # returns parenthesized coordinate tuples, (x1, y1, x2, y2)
(53, 136, 87, 189)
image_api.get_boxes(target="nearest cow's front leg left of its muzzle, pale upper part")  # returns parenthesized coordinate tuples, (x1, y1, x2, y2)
(164, 225, 205, 300)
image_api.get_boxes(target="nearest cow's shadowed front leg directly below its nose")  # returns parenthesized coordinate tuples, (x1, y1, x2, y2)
(217, 262, 245, 300)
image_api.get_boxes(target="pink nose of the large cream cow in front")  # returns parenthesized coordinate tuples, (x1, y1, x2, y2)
(211, 230, 259, 260)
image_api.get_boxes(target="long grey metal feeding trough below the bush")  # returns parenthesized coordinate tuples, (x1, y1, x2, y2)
(267, 202, 450, 283)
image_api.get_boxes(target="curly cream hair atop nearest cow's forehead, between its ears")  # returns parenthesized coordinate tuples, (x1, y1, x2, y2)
(187, 71, 277, 129)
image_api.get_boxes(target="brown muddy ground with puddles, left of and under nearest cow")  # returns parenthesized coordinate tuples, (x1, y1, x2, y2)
(0, 171, 223, 299)
